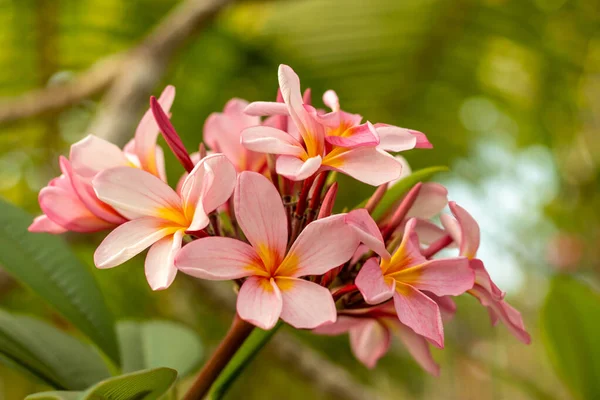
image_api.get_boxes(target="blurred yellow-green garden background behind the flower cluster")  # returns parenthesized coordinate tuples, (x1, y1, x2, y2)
(0, 0, 600, 400)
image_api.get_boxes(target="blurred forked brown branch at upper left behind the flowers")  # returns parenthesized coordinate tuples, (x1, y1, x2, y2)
(0, 0, 233, 128)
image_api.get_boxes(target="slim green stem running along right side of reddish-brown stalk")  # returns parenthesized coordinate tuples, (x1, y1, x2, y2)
(208, 321, 283, 400)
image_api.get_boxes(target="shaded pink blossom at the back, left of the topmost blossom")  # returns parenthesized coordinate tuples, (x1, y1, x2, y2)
(203, 99, 267, 172)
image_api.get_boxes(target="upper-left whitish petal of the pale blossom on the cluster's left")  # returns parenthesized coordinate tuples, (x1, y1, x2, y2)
(92, 167, 186, 225)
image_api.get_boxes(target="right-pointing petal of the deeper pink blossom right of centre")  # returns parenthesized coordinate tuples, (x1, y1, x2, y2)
(389, 257, 475, 296)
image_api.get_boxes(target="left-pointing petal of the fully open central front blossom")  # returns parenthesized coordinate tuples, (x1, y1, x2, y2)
(175, 237, 262, 281)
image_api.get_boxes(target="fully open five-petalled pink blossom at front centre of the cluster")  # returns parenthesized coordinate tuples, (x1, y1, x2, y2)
(175, 172, 383, 329)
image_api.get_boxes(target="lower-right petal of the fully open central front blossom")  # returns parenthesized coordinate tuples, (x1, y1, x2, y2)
(275, 278, 337, 329)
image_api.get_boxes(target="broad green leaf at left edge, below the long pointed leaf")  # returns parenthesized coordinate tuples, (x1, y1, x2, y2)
(0, 310, 110, 390)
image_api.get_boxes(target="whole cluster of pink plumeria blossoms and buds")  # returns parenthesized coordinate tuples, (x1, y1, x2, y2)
(30, 65, 530, 374)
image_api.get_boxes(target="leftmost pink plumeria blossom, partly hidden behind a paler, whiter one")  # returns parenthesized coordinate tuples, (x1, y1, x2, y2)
(29, 86, 175, 233)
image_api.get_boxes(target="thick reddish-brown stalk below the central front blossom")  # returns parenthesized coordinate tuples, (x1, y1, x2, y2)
(184, 314, 254, 400)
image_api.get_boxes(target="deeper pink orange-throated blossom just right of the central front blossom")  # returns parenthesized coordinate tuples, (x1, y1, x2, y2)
(356, 218, 474, 347)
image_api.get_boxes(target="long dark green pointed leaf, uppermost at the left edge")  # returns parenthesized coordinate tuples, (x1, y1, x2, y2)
(0, 199, 119, 362)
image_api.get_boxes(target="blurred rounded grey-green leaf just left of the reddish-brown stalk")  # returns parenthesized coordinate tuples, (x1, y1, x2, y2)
(117, 321, 203, 377)
